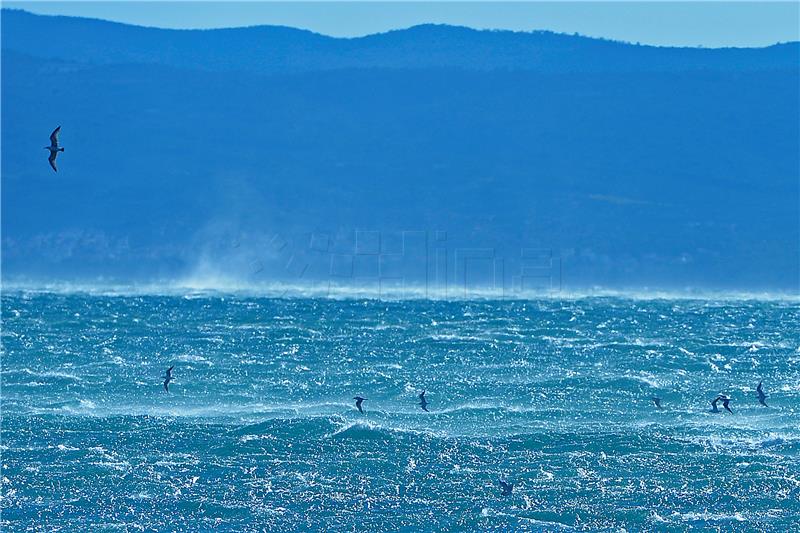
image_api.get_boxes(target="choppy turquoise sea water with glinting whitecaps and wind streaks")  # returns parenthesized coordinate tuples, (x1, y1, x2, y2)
(0, 291, 800, 531)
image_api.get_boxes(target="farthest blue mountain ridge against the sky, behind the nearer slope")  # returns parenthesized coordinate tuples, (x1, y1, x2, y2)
(2, 8, 800, 73)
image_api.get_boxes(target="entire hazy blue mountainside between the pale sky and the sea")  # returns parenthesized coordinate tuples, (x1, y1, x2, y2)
(2, 10, 800, 291)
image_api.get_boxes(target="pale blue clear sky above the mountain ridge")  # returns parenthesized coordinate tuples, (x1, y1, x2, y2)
(2, 0, 800, 47)
